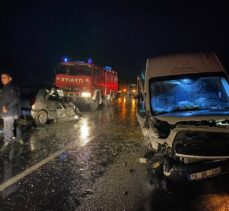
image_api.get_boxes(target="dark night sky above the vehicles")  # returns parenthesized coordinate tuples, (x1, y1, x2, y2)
(0, 0, 229, 83)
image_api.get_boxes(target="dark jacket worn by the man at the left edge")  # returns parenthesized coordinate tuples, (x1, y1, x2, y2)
(0, 83, 20, 117)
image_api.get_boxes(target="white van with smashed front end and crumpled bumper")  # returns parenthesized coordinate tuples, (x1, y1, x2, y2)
(137, 53, 229, 181)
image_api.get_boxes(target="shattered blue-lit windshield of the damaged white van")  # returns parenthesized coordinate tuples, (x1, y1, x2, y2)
(150, 76, 229, 114)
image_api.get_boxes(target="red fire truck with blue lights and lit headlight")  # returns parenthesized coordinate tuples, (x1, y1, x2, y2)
(55, 61, 118, 110)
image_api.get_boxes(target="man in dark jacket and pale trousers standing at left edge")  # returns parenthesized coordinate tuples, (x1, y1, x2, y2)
(0, 72, 19, 146)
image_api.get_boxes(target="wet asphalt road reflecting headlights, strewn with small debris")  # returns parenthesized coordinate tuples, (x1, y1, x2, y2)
(0, 99, 229, 211)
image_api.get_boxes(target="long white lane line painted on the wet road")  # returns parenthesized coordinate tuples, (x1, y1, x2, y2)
(0, 147, 67, 192)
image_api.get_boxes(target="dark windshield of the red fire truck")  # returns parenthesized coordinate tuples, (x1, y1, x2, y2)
(57, 65, 91, 75)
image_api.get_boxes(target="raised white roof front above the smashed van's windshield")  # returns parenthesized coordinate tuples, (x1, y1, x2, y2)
(146, 53, 224, 79)
